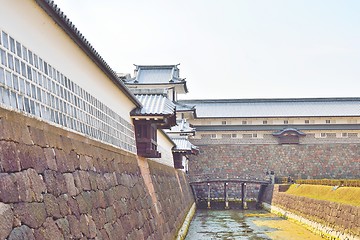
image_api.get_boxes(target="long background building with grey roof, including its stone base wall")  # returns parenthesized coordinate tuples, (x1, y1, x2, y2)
(180, 98, 360, 180)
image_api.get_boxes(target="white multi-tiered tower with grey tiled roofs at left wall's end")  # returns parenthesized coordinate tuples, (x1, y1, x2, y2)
(120, 64, 198, 169)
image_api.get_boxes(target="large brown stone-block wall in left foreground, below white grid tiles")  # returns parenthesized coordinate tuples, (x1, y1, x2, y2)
(0, 108, 194, 240)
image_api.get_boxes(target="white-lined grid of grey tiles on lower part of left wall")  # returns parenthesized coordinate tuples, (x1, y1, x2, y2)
(0, 30, 136, 152)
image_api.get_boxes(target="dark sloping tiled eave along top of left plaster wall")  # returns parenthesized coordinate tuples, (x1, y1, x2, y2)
(36, 0, 141, 106)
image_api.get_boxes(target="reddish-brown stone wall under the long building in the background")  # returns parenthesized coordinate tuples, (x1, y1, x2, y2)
(189, 140, 360, 180)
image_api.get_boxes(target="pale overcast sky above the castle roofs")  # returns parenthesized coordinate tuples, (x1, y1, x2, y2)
(55, 0, 360, 99)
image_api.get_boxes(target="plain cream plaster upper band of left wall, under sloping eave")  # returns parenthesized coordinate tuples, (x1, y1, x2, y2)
(0, 0, 135, 120)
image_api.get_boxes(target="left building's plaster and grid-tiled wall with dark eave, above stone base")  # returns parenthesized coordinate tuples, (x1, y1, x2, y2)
(0, 0, 141, 153)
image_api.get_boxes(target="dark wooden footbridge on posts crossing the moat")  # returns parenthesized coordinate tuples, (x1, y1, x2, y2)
(190, 178, 270, 209)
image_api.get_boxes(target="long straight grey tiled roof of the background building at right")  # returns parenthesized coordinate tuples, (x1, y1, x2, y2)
(179, 98, 360, 118)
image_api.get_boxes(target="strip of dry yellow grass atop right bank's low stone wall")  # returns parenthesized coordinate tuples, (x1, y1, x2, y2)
(286, 184, 360, 206)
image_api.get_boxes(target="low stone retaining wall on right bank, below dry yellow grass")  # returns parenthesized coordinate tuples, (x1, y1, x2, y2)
(265, 185, 360, 239)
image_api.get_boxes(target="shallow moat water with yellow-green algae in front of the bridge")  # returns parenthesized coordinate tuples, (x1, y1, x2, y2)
(186, 210, 322, 240)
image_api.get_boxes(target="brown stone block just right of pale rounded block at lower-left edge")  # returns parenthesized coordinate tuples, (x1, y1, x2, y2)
(14, 202, 46, 228)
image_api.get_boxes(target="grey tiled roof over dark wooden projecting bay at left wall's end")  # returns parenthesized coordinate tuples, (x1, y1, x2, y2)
(131, 94, 175, 116)
